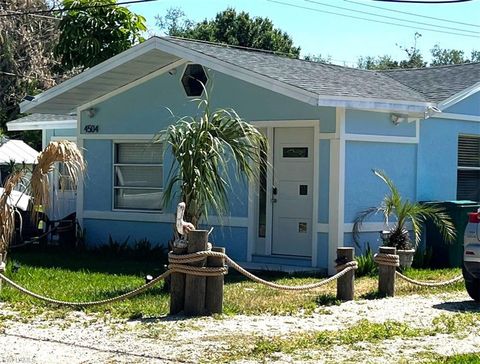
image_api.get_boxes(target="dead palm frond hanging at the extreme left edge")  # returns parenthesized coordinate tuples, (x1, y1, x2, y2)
(0, 170, 25, 257)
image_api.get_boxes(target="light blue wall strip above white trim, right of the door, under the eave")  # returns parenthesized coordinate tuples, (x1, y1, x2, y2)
(345, 110, 415, 137)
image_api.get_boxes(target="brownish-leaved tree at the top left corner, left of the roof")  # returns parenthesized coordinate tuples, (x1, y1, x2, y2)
(0, 0, 61, 149)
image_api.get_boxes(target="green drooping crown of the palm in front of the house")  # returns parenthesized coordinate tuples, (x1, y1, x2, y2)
(155, 95, 267, 226)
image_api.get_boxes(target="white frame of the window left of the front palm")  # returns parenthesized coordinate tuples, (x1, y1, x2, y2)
(111, 139, 165, 214)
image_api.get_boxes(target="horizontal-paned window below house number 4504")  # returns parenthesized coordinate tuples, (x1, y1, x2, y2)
(113, 142, 163, 211)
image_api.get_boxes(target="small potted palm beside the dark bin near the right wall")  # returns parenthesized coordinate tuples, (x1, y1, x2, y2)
(353, 170, 456, 268)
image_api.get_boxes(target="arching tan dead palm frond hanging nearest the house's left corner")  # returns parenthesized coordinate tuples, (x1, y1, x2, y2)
(30, 140, 85, 213)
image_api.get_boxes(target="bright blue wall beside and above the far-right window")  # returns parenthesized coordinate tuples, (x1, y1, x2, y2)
(417, 118, 480, 201)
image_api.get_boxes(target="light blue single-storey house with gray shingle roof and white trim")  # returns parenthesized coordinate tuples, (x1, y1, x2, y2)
(10, 38, 480, 272)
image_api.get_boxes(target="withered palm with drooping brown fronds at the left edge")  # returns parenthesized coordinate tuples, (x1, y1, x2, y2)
(0, 140, 85, 257)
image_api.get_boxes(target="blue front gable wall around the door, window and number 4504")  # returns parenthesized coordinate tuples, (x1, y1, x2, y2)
(80, 69, 335, 249)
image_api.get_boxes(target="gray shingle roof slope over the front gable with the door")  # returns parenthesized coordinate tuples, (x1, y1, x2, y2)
(164, 37, 426, 102)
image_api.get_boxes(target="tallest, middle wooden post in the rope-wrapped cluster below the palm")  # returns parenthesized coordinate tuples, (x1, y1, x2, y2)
(184, 230, 208, 316)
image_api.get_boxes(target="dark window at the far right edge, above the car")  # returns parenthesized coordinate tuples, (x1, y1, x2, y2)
(457, 135, 480, 201)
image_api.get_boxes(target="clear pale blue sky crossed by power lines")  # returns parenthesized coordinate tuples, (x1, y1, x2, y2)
(128, 0, 480, 66)
